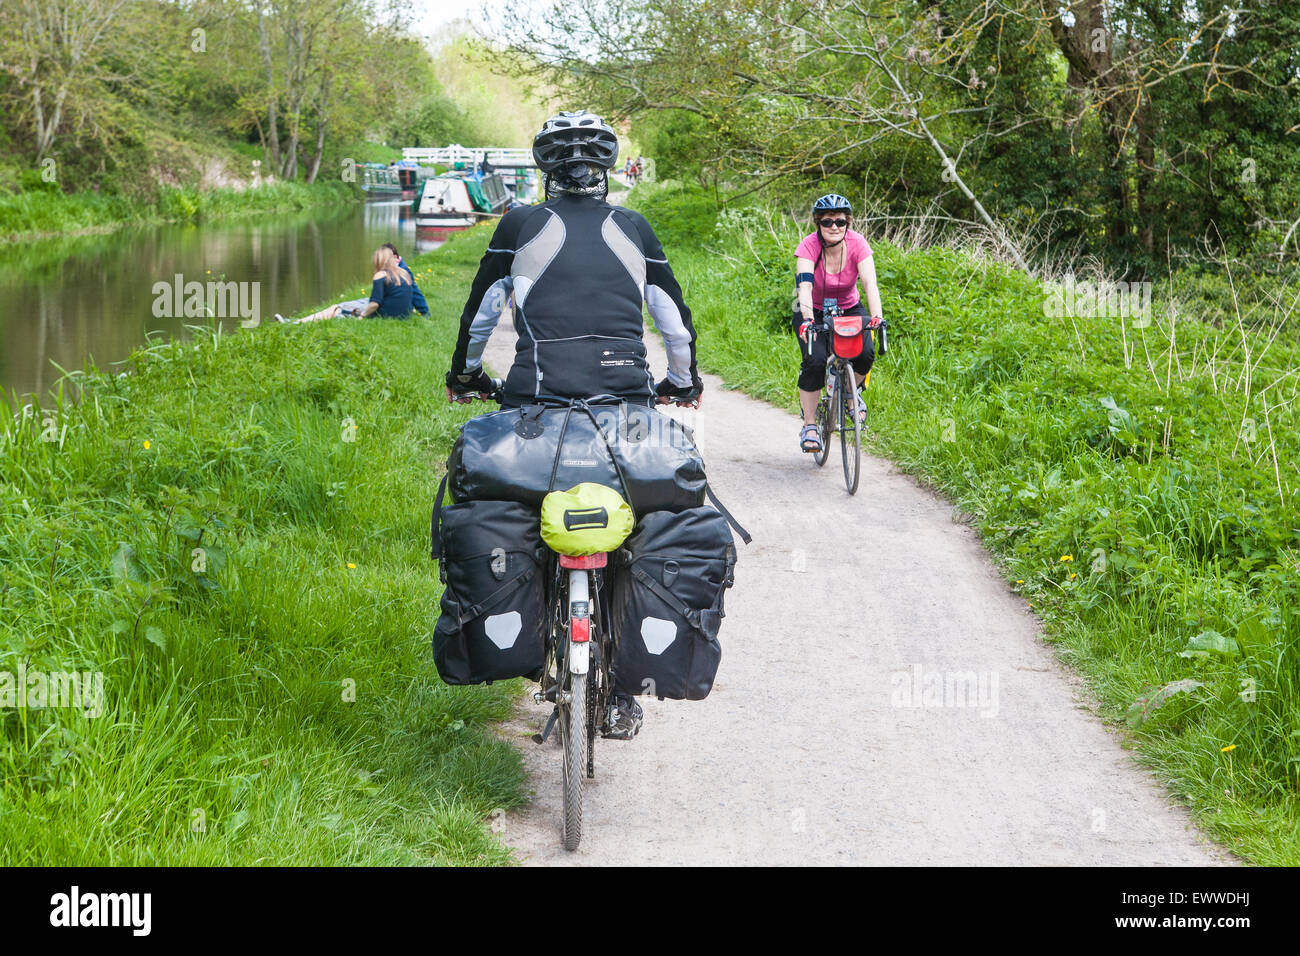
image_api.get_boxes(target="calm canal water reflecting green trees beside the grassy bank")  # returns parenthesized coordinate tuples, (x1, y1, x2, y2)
(0, 200, 447, 397)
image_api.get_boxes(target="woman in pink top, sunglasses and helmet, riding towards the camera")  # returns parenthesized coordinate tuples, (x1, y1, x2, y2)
(792, 193, 881, 453)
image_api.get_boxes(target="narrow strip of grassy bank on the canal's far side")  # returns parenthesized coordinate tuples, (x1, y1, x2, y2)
(0, 181, 361, 242)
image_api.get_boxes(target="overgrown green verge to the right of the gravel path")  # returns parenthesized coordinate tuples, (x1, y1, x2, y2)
(632, 180, 1300, 865)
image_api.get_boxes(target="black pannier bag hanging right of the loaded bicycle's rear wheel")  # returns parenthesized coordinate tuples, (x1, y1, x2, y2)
(610, 507, 736, 700)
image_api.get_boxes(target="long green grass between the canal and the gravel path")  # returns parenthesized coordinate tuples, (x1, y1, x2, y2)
(0, 230, 524, 865)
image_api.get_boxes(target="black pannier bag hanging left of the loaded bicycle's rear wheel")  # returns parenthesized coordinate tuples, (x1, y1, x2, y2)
(433, 488, 546, 684)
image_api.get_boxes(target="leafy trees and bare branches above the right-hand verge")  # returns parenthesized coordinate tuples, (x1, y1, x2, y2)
(512, 0, 1300, 269)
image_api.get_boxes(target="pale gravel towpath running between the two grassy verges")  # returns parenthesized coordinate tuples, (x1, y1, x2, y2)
(486, 306, 1232, 865)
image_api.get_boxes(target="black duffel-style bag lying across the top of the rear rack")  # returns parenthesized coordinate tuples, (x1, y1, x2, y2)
(447, 405, 707, 515)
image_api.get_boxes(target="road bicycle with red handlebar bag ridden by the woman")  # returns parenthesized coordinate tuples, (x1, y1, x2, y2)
(807, 299, 889, 494)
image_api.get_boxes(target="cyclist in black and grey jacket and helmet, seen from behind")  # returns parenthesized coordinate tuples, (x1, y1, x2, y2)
(447, 111, 703, 407)
